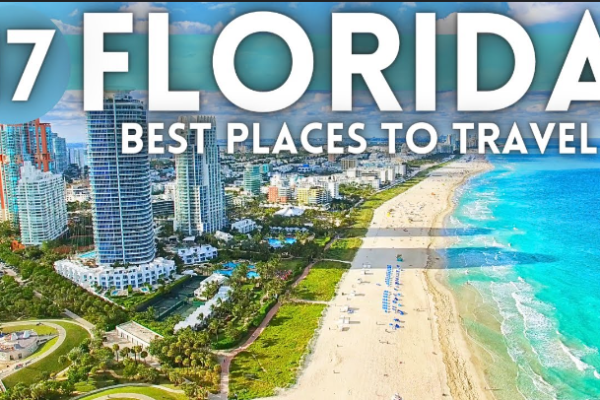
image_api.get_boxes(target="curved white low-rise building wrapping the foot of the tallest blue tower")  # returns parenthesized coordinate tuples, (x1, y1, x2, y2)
(54, 257, 176, 289)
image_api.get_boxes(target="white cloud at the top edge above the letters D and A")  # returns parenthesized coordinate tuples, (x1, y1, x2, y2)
(508, 2, 594, 25)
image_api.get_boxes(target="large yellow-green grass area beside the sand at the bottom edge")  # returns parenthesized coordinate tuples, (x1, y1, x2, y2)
(229, 303, 325, 400)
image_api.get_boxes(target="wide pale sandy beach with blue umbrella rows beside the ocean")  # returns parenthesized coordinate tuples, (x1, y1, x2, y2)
(264, 156, 493, 400)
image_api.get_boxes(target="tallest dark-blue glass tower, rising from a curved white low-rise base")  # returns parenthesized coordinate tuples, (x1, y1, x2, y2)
(87, 93, 156, 265)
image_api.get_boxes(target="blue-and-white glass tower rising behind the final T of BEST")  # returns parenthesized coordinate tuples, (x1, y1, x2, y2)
(175, 116, 227, 235)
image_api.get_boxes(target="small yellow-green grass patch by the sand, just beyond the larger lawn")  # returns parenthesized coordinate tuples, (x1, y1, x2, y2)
(292, 261, 350, 301)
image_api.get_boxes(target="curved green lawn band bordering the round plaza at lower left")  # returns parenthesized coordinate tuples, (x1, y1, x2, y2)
(3, 321, 90, 387)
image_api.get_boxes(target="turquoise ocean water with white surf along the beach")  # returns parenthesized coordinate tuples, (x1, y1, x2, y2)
(445, 155, 600, 400)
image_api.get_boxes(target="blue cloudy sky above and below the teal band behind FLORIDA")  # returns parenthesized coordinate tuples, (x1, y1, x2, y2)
(15, 2, 600, 142)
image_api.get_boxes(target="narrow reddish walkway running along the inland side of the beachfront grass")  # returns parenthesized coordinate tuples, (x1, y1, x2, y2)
(215, 238, 337, 399)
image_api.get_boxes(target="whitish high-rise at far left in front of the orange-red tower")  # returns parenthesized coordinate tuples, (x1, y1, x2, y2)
(17, 161, 67, 245)
